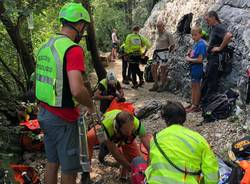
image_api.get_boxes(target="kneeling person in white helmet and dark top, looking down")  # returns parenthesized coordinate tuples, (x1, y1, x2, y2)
(95, 71, 125, 113)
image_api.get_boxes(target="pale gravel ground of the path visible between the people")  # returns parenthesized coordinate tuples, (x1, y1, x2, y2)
(29, 61, 249, 184)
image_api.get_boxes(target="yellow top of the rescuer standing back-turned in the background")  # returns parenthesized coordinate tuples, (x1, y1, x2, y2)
(124, 33, 151, 54)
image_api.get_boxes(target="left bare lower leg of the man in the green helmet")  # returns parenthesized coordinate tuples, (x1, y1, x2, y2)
(44, 162, 59, 184)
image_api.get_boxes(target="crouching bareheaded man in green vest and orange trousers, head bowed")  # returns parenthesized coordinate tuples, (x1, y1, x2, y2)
(87, 110, 149, 179)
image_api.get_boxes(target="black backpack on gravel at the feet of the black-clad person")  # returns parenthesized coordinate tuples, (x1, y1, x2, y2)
(202, 90, 239, 122)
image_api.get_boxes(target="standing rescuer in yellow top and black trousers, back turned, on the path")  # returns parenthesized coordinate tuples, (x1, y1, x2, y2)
(124, 26, 151, 89)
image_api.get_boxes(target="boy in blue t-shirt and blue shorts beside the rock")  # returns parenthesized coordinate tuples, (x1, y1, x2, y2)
(186, 27, 207, 112)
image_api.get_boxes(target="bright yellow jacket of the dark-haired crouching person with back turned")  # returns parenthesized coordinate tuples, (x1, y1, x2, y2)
(145, 125, 218, 184)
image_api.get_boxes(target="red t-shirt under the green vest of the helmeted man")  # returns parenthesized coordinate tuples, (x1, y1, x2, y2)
(40, 46, 85, 123)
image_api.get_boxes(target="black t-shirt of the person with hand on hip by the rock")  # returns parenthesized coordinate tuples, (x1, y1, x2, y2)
(208, 24, 227, 52)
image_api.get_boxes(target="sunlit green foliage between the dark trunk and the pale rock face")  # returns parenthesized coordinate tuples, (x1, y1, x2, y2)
(92, 0, 152, 51)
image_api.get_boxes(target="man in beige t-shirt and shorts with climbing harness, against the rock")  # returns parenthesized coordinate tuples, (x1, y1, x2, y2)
(149, 21, 175, 92)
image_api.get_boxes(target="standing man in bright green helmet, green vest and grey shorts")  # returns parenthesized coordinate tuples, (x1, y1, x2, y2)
(36, 3, 94, 184)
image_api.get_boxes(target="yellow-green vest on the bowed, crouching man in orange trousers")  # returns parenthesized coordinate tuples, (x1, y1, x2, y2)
(102, 110, 141, 139)
